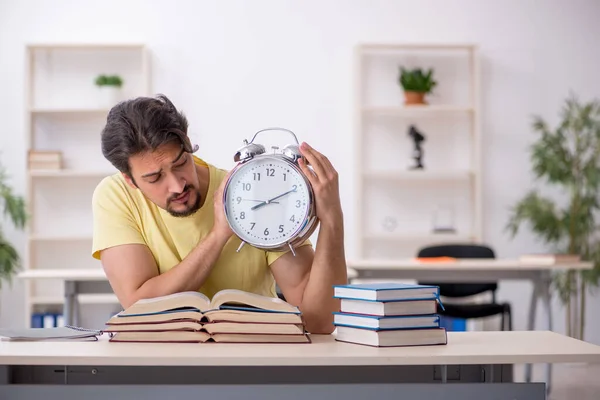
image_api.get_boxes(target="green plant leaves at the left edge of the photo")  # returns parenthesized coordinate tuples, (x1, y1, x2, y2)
(0, 161, 27, 286)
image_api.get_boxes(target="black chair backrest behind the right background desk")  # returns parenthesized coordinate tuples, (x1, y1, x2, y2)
(417, 244, 498, 297)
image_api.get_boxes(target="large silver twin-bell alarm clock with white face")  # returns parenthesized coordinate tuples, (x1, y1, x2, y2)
(223, 128, 318, 255)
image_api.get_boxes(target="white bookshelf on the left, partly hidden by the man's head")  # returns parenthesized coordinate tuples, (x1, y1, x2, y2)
(24, 43, 153, 326)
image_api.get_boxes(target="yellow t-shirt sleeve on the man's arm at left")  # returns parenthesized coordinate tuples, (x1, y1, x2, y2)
(92, 176, 146, 260)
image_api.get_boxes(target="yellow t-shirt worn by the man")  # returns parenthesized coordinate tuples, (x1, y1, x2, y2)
(92, 156, 310, 298)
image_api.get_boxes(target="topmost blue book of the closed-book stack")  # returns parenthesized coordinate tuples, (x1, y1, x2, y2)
(333, 282, 440, 301)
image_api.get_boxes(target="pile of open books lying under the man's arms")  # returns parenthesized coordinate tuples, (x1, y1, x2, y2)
(104, 289, 310, 343)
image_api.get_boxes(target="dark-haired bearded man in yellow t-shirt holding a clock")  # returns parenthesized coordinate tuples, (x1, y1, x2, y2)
(92, 95, 347, 333)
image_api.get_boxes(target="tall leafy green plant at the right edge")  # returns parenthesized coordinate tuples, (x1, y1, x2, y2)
(507, 95, 600, 339)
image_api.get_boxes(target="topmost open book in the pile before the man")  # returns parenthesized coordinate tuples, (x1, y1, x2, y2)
(119, 289, 300, 317)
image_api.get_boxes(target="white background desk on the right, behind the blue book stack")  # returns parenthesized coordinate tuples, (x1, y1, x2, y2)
(347, 258, 593, 384)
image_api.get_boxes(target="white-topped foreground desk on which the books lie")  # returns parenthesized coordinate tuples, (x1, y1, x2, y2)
(0, 331, 600, 400)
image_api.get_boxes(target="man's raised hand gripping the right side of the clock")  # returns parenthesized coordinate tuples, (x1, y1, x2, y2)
(299, 143, 343, 224)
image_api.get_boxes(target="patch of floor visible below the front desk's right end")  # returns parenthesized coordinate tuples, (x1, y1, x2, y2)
(514, 364, 600, 400)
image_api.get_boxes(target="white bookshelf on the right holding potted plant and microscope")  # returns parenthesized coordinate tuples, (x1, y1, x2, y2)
(354, 43, 482, 259)
